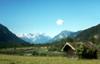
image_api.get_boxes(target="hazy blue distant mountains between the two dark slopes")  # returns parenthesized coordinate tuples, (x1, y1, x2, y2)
(18, 30, 79, 44)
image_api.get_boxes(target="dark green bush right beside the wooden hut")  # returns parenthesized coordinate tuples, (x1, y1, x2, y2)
(76, 44, 97, 59)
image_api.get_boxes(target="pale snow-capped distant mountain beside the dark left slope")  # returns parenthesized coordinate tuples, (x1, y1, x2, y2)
(18, 33, 51, 44)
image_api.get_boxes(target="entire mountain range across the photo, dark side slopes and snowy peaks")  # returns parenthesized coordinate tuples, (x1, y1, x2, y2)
(0, 24, 100, 48)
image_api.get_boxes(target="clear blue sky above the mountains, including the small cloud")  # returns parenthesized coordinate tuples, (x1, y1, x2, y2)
(0, 0, 100, 36)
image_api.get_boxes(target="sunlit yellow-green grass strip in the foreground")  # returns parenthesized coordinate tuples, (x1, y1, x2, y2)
(0, 55, 100, 64)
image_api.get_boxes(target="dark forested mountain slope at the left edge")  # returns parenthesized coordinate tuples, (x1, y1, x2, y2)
(0, 24, 30, 48)
